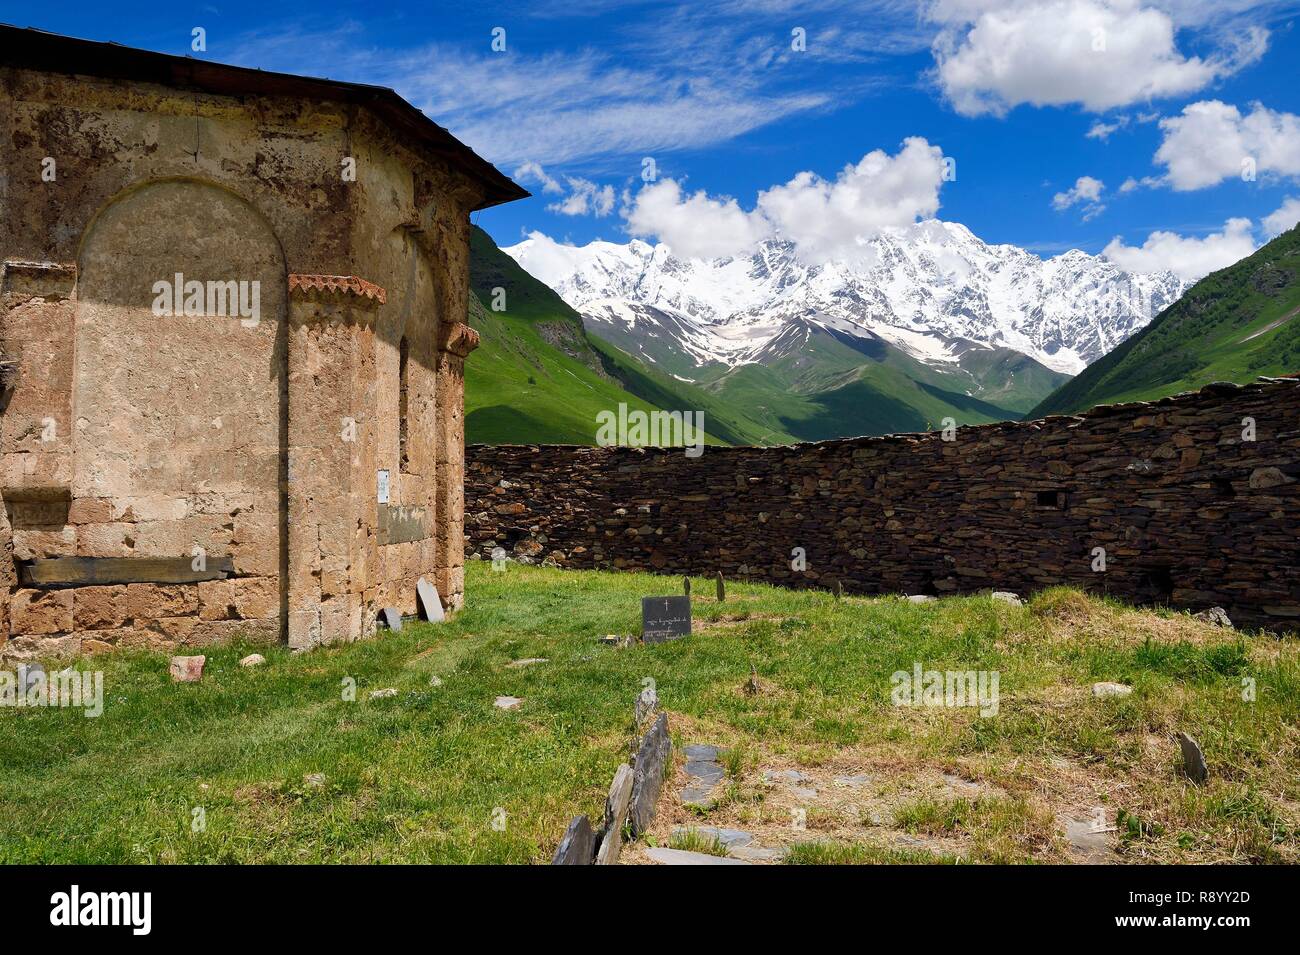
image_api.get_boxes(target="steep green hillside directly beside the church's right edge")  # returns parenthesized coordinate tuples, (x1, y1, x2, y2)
(465, 227, 792, 444)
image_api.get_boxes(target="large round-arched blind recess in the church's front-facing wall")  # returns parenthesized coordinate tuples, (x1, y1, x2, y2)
(73, 179, 287, 631)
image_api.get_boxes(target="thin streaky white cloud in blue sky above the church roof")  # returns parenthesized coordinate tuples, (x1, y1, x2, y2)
(223, 0, 923, 169)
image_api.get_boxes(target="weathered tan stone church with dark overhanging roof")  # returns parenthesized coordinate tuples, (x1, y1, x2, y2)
(0, 27, 528, 659)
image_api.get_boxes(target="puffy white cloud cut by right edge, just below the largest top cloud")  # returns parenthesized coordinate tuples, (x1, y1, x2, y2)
(1156, 100, 1300, 191)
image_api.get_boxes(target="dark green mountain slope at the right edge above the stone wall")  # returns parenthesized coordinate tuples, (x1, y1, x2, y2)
(1030, 229, 1300, 417)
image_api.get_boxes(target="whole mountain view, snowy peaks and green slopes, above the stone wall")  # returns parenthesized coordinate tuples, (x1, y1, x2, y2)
(465, 220, 1300, 444)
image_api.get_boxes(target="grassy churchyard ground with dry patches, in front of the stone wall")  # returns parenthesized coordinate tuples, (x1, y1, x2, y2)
(0, 563, 1300, 863)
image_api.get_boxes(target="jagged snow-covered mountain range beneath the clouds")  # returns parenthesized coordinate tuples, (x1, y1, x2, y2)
(503, 220, 1188, 374)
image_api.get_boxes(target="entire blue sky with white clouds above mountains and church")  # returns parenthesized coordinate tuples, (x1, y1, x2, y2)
(15, 0, 1300, 275)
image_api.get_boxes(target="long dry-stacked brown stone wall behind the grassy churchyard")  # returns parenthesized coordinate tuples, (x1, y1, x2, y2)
(465, 378, 1300, 633)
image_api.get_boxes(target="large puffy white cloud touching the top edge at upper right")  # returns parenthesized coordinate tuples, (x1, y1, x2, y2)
(930, 0, 1268, 116)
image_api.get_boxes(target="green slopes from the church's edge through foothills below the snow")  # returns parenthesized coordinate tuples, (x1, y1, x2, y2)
(465, 227, 1066, 444)
